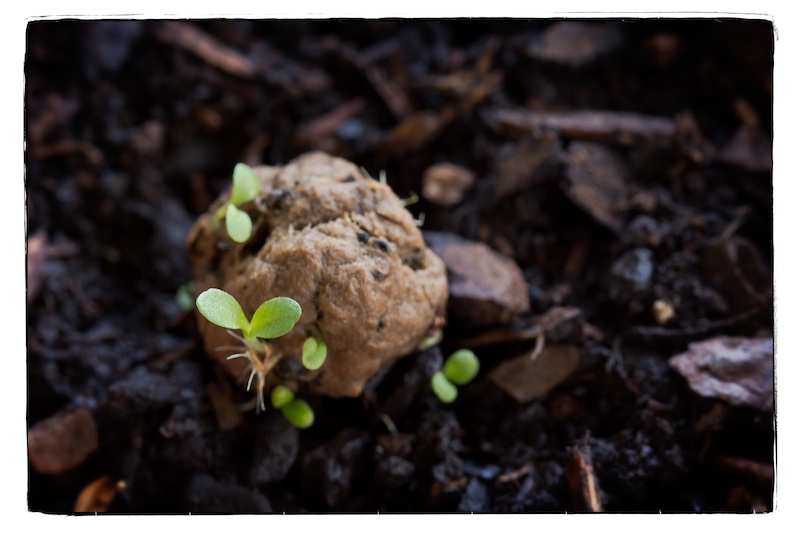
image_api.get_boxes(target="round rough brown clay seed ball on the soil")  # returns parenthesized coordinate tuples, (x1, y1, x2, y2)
(187, 152, 447, 397)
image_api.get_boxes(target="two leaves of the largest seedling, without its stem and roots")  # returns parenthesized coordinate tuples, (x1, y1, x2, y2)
(196, 288, 302, 341)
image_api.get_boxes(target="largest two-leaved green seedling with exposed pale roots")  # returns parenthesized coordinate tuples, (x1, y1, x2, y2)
(196, 288, 302, 411)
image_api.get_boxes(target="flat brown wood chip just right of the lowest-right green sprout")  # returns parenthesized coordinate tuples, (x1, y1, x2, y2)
(489, 345, 580, 403)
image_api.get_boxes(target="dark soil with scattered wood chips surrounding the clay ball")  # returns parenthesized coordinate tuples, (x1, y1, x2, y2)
(25, 20, 774, 513)
